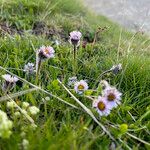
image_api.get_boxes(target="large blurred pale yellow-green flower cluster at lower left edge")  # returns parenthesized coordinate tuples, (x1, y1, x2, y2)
(0, 110, 12, 138)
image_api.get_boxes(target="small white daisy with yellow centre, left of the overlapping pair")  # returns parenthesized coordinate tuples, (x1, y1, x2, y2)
(74, 80, 88, 94)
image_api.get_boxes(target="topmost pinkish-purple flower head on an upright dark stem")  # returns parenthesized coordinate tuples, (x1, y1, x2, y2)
(69, 31, 82, 46)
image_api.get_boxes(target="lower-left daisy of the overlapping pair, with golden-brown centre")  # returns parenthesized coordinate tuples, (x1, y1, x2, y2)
(93, 96, 111, 116)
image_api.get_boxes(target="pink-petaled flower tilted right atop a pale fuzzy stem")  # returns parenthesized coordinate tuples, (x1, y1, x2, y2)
(38, 46, 55, 59)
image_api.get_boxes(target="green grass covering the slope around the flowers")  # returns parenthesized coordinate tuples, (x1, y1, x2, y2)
(0, 0, 150, 150)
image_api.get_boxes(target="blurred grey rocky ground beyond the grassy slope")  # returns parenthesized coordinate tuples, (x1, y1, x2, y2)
(83, 0, 150, 33)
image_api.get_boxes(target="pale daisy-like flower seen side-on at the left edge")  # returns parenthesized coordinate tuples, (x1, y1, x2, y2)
(2, 74, 19, 91)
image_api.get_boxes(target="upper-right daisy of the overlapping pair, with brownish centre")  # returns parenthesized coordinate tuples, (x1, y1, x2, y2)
(102, 87, 122, 108)
